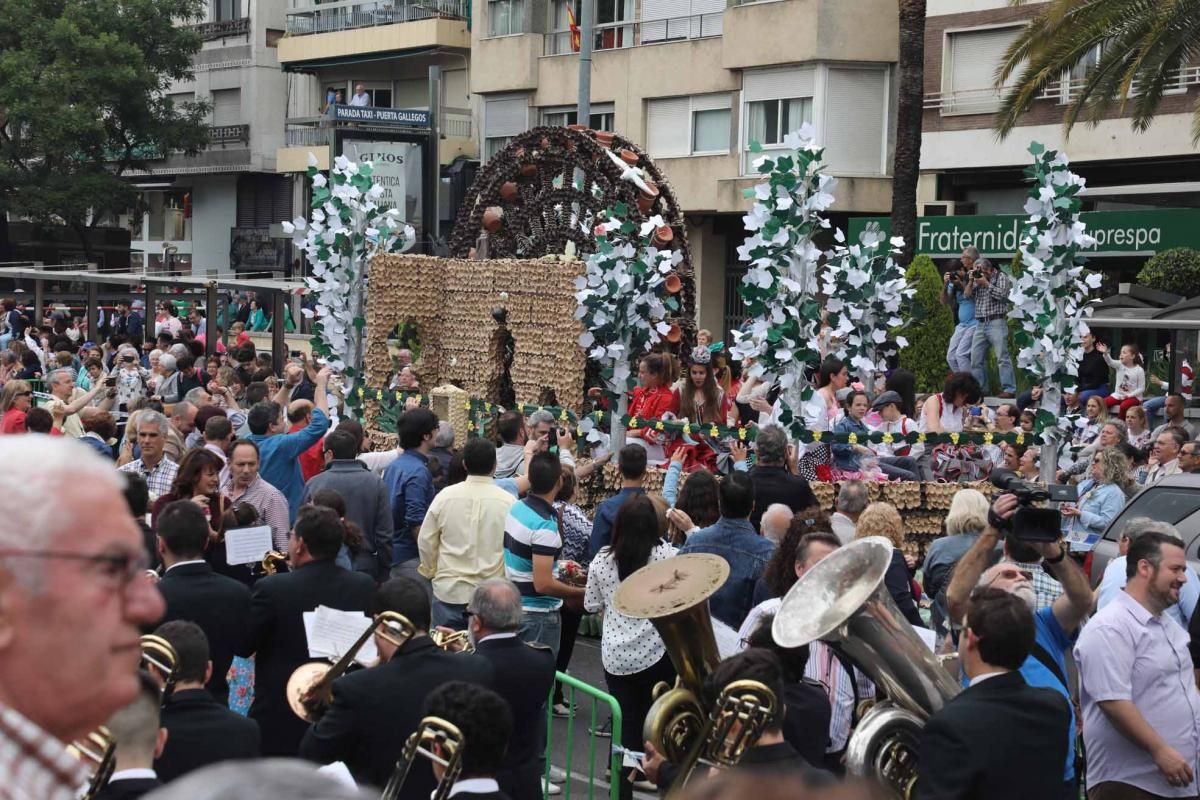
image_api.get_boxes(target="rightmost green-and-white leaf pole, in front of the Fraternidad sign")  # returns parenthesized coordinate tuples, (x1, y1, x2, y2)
(1008, 142, 1100, 481)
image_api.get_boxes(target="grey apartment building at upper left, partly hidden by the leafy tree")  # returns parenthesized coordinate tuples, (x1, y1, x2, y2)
(121, 0, 293, 275)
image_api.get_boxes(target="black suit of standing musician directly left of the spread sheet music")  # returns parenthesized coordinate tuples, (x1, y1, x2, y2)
(238, 559, 376, 760)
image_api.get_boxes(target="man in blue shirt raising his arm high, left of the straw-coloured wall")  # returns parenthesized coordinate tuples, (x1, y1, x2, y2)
(246, 367, 330, 523)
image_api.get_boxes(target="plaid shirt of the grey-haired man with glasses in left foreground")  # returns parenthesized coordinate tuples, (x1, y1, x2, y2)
(0, 705, 88, 800)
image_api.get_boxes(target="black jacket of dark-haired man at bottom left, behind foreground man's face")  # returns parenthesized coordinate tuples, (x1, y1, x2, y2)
(154, 688, 262, 782)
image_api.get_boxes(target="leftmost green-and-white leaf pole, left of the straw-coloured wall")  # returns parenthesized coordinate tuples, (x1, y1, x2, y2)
(283, 154, 415, 408)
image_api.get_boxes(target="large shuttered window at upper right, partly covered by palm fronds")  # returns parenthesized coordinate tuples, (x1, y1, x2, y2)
(942, 25, 1021, 114)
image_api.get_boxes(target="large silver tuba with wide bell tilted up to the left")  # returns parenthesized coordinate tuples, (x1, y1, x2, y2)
(772, 536, 959, 798)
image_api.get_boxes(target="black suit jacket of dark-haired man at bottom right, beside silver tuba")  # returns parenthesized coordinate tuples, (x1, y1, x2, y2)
(913, 672, 1070, 800)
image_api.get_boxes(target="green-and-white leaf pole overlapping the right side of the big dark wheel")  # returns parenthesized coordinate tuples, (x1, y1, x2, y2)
(575, 203, 683, 450)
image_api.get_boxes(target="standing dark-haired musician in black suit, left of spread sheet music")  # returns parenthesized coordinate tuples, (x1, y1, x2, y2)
(236, 506, 374, 756)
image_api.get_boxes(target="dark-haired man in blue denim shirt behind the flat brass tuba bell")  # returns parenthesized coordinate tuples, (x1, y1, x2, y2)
(679, 473, 775, 630)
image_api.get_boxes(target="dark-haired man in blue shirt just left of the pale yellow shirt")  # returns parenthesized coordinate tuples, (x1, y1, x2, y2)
(383, 408, 438, 566)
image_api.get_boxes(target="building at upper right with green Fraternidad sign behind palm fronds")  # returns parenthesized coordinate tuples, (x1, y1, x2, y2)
(917, 0, 1200, 278)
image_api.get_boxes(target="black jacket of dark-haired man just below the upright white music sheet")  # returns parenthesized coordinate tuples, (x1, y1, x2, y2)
(158, 564, 250, 704)
